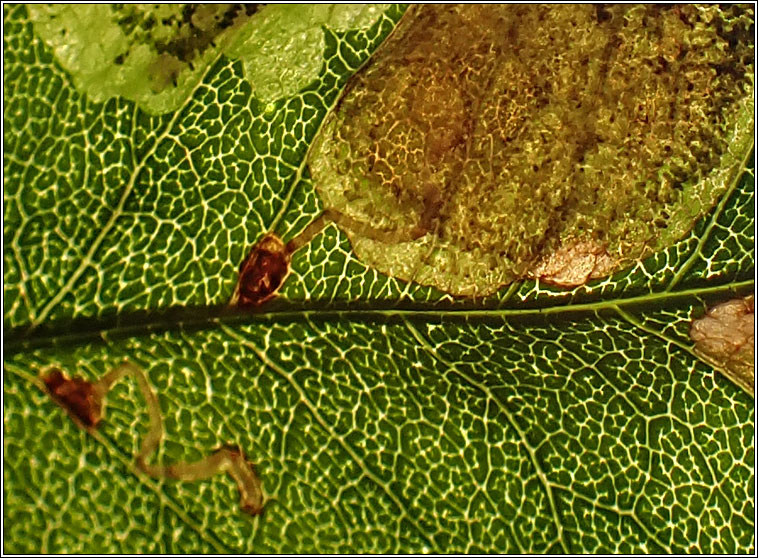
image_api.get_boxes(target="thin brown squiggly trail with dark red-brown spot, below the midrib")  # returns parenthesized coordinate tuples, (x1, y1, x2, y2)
(41, 362, 264, 515)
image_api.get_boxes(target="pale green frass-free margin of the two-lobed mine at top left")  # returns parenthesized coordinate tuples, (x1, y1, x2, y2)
(27, 4, 388, 114)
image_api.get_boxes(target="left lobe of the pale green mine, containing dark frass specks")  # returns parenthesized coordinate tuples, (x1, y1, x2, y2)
(28, 4, 259, 114)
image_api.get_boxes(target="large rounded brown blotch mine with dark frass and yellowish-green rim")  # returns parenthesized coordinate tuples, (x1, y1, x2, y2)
(309, 4, 753, 295)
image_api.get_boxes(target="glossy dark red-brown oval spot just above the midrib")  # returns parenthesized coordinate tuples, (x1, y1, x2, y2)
(231, 233, 290, 307)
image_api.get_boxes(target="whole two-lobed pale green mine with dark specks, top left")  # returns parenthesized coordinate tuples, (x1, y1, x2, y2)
(29, 4, 387, 114)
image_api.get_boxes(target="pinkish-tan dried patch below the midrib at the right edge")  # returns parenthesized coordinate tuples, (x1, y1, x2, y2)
(690, 296, 755, 395)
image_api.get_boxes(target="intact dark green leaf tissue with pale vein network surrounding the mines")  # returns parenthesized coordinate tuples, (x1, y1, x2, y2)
(3, 5, 755, 553)
